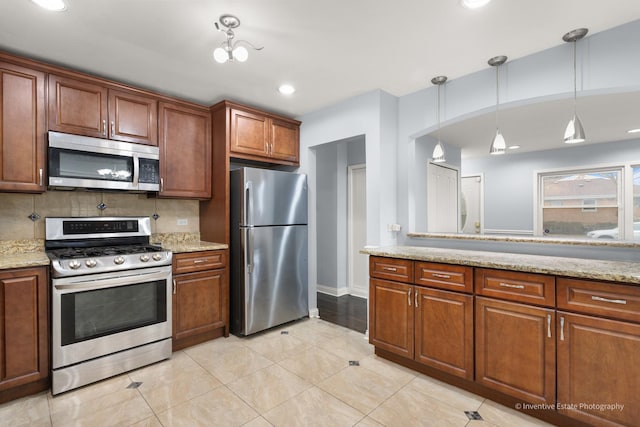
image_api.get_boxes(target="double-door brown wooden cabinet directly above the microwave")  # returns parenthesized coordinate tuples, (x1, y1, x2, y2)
(49, 74, 158, 145)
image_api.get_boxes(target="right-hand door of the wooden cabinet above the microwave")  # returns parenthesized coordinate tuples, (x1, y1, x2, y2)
(109, 90, 158, 145)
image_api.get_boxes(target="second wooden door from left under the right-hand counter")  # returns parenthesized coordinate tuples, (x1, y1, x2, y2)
(414, 286, 473, 380)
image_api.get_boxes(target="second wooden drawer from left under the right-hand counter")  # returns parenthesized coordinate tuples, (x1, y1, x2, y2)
(414, 262, 473, 293)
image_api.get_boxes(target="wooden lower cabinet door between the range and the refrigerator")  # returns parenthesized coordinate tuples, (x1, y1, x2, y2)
(173, 269, 229, 340)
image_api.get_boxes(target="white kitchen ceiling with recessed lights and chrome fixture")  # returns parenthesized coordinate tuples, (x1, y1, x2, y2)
(0, 0, 640, 155)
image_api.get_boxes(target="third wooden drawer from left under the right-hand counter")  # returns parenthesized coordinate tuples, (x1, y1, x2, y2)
(475, 268, 556, 307)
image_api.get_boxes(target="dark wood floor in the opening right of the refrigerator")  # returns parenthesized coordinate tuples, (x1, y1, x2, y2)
(318, 292, 367, 333)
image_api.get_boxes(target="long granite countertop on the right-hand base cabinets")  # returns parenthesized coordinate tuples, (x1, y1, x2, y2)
(360, 246, 640, 284)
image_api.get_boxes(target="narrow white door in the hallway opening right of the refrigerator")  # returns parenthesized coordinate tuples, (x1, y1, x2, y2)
(347, 164, 369, 298)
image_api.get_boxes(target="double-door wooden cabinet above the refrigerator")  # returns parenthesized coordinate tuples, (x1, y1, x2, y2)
(225, 101, 300, 166)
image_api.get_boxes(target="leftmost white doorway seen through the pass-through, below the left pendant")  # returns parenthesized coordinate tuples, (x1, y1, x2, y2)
(427, 163, 459, 233)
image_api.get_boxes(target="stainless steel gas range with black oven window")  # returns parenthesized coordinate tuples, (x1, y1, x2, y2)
(45, 217, 172, 395)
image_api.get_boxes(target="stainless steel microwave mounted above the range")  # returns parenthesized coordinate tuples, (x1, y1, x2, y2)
(49, 132, 160, 192)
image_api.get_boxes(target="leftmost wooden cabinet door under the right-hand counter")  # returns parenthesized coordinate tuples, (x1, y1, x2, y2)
(369, 279, 414, 359)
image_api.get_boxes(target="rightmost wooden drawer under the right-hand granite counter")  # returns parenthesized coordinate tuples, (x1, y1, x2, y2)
(557, 277, 640, 322)
